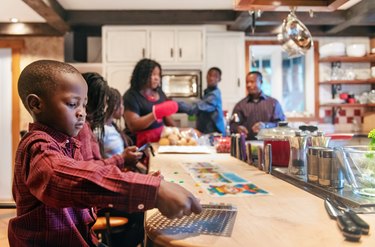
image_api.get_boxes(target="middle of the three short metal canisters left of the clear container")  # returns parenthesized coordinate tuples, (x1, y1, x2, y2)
(318, 148, 333, 186)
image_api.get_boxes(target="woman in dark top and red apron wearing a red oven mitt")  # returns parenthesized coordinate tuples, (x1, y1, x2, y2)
(123, 59, 178, 147)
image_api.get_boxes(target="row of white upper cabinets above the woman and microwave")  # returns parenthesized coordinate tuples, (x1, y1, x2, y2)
(102, 26, 206, 66)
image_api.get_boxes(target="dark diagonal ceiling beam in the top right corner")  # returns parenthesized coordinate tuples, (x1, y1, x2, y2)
(327, 0, 375, 34)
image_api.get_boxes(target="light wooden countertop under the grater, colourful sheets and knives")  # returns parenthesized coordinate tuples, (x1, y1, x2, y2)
(146, 153, 375, 247)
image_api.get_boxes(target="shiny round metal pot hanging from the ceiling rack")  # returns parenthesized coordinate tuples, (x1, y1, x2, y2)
(277, 10, 313, 57)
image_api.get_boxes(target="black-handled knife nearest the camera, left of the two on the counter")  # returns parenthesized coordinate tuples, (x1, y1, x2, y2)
(324, 199, 362, 242)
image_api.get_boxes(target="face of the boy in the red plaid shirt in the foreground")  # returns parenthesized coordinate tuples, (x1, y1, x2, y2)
(37, 73, 88, 136)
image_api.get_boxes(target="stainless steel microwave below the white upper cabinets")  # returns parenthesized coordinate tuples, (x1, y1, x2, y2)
(161, 70, 202, 98)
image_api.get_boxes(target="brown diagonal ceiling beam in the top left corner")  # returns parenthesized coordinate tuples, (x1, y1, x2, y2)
(22, 0, 70, 35)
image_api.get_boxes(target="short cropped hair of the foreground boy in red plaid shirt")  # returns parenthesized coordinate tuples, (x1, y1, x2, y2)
(18, 60, 79, 108)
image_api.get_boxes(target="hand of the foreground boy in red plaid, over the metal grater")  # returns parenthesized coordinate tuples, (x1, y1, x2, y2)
(156, 180, 202, 219)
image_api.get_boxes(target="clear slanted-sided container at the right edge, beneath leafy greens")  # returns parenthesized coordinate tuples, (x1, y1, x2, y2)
(335, 145, 375, 197)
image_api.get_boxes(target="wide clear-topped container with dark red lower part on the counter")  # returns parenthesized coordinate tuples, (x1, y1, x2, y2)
(257, 122, 295, 167)
